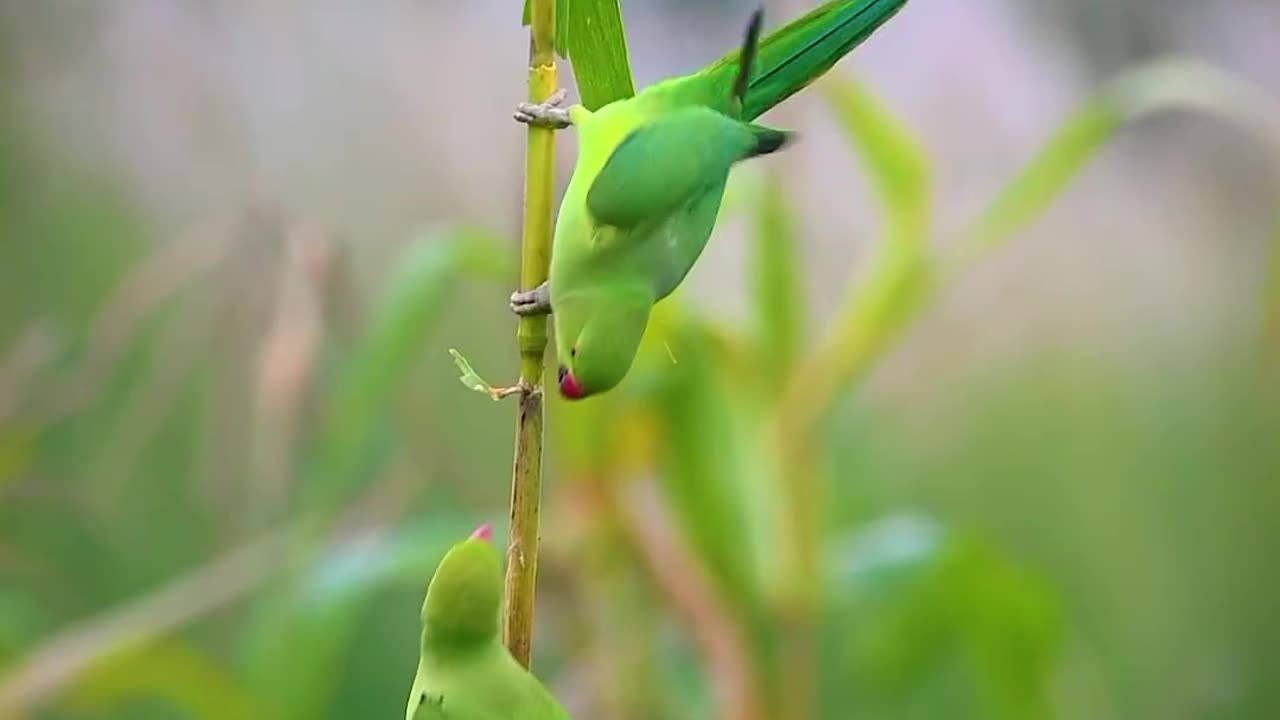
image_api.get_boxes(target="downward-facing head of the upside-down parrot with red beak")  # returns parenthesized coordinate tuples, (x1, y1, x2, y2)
(556, 290, 653, 400)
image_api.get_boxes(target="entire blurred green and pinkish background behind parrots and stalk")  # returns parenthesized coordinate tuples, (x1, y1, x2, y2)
(0, 0, 1280, 720)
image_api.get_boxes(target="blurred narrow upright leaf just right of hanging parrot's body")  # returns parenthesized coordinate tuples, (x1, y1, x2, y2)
(751, 176, 805, 389)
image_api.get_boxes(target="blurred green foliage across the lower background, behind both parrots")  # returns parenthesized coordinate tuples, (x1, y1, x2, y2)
(0, 3, 1280, 720)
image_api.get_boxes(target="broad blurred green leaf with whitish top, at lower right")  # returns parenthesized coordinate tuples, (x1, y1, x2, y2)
(823, 514, 1064, 720)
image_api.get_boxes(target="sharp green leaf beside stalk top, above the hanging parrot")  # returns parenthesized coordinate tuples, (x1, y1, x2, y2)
(557, 0, 635, 110)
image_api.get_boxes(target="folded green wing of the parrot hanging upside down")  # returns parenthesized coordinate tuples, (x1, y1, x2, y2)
(586, 106, 788, 228)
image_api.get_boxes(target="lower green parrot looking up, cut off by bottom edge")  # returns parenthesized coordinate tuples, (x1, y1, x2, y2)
(404, 525, 570, 720)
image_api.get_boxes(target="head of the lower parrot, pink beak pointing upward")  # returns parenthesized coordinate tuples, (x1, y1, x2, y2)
(422, 524, 502, 646)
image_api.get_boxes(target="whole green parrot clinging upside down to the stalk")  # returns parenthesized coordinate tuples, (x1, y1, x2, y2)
(512, 0, 906, 398)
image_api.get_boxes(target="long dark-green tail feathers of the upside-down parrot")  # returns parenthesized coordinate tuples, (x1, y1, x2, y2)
(704, 0, 908, 120)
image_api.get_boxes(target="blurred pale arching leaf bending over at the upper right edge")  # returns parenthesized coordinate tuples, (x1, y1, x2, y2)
(961, 60, 1280, 260)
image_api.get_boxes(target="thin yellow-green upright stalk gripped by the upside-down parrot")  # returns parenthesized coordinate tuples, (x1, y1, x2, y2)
(502, 0, 556, 667)
